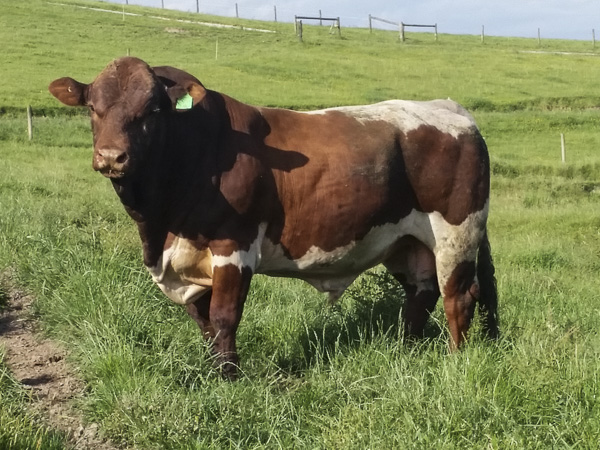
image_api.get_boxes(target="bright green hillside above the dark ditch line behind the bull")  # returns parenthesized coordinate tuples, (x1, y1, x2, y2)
(0, 0, 600, 111)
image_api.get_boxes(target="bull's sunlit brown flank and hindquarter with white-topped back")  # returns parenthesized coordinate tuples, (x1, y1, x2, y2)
(263, 100, 489, 243)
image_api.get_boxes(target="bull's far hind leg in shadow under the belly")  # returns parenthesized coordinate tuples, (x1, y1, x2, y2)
(385, 238, 440, 337)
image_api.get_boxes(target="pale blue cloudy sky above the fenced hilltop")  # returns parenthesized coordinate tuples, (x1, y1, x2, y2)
(112, 0, 600, 40)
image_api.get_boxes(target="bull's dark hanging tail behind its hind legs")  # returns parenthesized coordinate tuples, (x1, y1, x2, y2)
(477, 231, 499, 339)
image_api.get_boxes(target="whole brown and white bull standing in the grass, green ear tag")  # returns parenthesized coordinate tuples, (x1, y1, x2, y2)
(49, 57, 498, 378)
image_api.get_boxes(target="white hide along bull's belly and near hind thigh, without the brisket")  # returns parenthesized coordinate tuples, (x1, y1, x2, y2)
(256, 203, 488, 298)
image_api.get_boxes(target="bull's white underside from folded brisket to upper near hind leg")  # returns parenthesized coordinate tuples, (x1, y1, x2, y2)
(148, 204, 488, 304)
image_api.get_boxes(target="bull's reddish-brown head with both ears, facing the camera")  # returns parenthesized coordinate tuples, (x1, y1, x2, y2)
(49, 57, 205, 179)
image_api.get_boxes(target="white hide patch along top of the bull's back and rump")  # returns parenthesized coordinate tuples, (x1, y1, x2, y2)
(306, 100, 476, 138)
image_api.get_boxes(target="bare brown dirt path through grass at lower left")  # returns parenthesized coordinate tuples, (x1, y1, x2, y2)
(0, 273, 118, 450)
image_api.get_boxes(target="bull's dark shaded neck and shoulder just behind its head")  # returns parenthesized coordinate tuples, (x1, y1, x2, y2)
(113, 92, 229, 266)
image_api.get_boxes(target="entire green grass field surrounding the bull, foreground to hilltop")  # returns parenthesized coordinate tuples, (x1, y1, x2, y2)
(0, 0, 600, 449)
